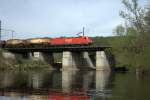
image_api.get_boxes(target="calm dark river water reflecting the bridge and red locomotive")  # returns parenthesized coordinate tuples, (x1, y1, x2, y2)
(0, 71, 150, 100)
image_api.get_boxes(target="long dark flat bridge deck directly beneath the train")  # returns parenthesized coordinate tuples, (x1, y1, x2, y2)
(4, 46, 111, 52)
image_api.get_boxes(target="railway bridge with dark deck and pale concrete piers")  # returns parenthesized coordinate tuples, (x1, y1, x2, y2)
(3, 46, 113, 71)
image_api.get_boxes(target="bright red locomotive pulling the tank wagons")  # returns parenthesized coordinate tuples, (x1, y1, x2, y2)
(51, 36, 92, 46)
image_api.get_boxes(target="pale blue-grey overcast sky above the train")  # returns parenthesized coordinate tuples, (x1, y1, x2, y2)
(0, 0, 146, 38)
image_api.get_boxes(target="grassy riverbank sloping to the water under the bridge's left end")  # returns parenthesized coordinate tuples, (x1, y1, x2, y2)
(0, 49, 52, 70)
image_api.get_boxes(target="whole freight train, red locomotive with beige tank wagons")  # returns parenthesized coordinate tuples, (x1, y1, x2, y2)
(0, 36, 93, 48)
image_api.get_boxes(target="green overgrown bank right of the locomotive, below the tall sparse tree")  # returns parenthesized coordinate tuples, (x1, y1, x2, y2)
(93, 36, 150, 72)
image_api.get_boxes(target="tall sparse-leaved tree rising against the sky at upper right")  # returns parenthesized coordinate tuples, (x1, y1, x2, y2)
(120, 0, 145, 34)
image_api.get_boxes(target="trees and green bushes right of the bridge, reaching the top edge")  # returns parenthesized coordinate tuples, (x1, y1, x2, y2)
(110, 0, 150, 69)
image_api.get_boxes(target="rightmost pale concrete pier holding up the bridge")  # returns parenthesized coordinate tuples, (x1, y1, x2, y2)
(96, 51, 111, 71)
